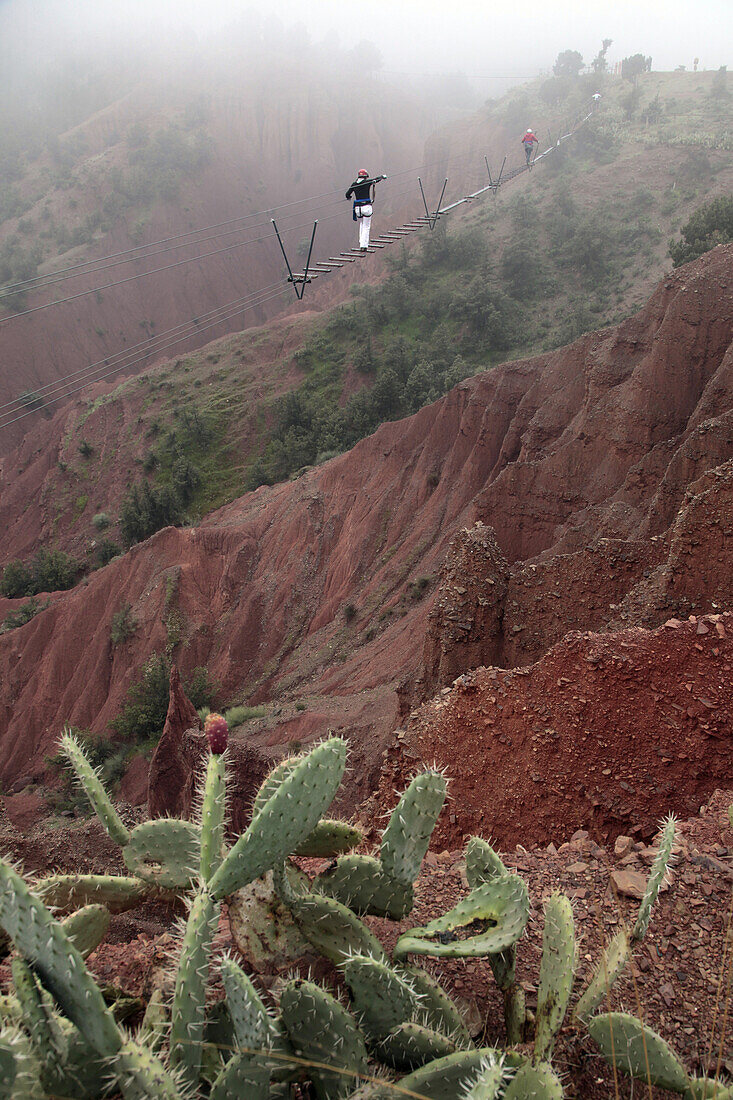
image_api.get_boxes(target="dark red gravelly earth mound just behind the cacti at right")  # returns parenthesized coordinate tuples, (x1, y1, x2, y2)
(372, 613, 733, 847)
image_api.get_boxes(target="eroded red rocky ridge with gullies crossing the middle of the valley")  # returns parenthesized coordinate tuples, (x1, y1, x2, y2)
(0, 246, 733, 818)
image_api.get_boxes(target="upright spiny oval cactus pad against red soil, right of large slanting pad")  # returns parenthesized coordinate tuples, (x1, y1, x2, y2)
(380, 771, 447, 887)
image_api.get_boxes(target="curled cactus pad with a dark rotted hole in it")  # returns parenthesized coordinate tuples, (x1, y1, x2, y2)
(394, 875, 529, 960)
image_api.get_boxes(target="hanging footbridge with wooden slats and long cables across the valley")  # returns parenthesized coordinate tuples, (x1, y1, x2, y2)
(0, 101, 593, 429)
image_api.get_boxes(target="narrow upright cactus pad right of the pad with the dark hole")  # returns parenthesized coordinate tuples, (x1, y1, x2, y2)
(534, 894, 576, 1063)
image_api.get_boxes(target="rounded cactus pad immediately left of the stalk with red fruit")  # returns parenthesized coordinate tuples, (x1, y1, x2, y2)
(122, 817, 201, 890)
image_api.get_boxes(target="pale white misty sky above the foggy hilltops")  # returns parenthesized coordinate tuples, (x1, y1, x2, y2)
(0, 0, 733, 89)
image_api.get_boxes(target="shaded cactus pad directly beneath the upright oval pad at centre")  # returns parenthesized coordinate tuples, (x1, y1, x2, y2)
(314, 855, 413, 921)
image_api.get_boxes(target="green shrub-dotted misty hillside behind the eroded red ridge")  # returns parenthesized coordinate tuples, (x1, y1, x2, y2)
(0, 74, 733, 565)
